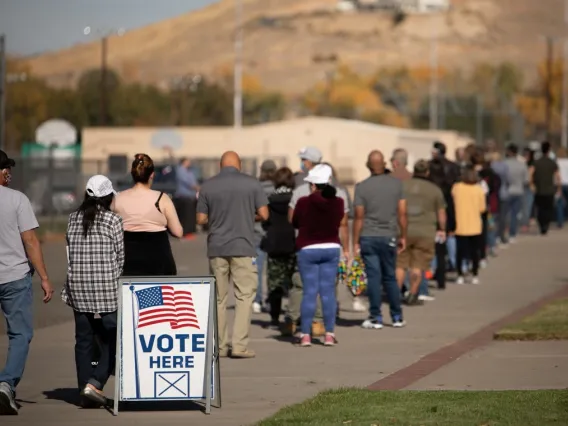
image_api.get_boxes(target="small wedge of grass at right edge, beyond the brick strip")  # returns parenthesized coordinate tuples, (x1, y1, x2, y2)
(495, 299, 568, 340)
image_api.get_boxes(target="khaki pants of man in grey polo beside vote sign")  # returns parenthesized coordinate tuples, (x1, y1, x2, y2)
(209, 257, 258, 352)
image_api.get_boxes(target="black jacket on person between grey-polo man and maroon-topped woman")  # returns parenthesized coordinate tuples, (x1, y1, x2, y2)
(260, 187, 296, 257)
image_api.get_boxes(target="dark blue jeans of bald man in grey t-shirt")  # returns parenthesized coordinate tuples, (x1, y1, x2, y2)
(360, 237, 402, 322)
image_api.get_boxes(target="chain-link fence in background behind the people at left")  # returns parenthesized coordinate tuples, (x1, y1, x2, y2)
(10, 156, 286, 232)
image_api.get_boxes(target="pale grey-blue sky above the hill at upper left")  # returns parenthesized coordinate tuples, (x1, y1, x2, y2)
(0, 0, 215, 55)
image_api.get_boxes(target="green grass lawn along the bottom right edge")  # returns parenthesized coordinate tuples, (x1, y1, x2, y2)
(258, 389, 568, 426)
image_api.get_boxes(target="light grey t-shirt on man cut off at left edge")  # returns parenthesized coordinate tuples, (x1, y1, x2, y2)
(0, 186, 39, 285)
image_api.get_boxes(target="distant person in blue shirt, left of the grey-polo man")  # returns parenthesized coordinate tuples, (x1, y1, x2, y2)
(174, 157, 199, 240)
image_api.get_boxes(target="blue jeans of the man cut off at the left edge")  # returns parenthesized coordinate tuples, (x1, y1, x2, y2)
(0, 274, 33, 389)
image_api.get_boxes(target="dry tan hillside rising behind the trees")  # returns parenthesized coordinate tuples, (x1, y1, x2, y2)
(21, 0, 566, 93)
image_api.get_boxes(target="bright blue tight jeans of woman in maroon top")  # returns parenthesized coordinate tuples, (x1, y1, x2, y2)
(298, 248, 340, 334)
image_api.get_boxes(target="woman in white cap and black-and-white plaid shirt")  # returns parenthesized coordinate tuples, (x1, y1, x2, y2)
(62, 175, 124, 408)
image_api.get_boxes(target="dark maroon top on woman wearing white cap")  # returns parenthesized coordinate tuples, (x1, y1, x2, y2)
(292, 191, 345, 250)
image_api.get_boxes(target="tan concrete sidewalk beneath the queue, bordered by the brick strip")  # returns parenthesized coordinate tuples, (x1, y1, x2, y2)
(0, 232, 568, 426)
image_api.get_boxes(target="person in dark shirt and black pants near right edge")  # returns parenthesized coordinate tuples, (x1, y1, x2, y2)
(532, 142, 562, 235)
